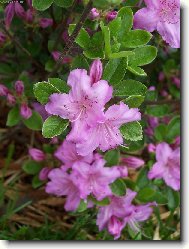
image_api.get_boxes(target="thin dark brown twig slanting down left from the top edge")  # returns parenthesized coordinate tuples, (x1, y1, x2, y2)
(49, 0, 93, 77)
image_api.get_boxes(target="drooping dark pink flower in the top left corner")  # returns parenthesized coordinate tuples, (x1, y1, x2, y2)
(5, 1, 26, 28)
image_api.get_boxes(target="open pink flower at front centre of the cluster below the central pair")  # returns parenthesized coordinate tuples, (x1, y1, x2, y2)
(72, 159, 120, 201)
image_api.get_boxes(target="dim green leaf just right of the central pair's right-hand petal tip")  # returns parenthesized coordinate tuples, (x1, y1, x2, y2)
(146, 105, 170, 117)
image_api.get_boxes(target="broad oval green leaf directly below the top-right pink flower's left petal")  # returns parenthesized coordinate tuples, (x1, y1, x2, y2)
(121, 30, 152, 48)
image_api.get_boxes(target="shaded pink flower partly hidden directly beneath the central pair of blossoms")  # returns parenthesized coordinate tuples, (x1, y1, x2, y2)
(54, 140, 93, 168)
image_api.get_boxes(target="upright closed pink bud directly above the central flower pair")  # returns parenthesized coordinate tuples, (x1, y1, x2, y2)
(90, 59, 103, 84)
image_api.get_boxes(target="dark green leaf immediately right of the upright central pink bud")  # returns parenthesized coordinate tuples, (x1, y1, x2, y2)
(102, 58, 127, 86)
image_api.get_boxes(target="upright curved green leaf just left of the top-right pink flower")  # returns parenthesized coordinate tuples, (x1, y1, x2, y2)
(117, 7, 133, 40)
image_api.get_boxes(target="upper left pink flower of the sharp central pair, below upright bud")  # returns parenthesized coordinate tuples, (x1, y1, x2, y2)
(45, 69, 112, 142)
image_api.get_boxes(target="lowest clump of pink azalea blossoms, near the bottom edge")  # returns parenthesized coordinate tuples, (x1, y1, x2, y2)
(97, 189, 156, 239)
